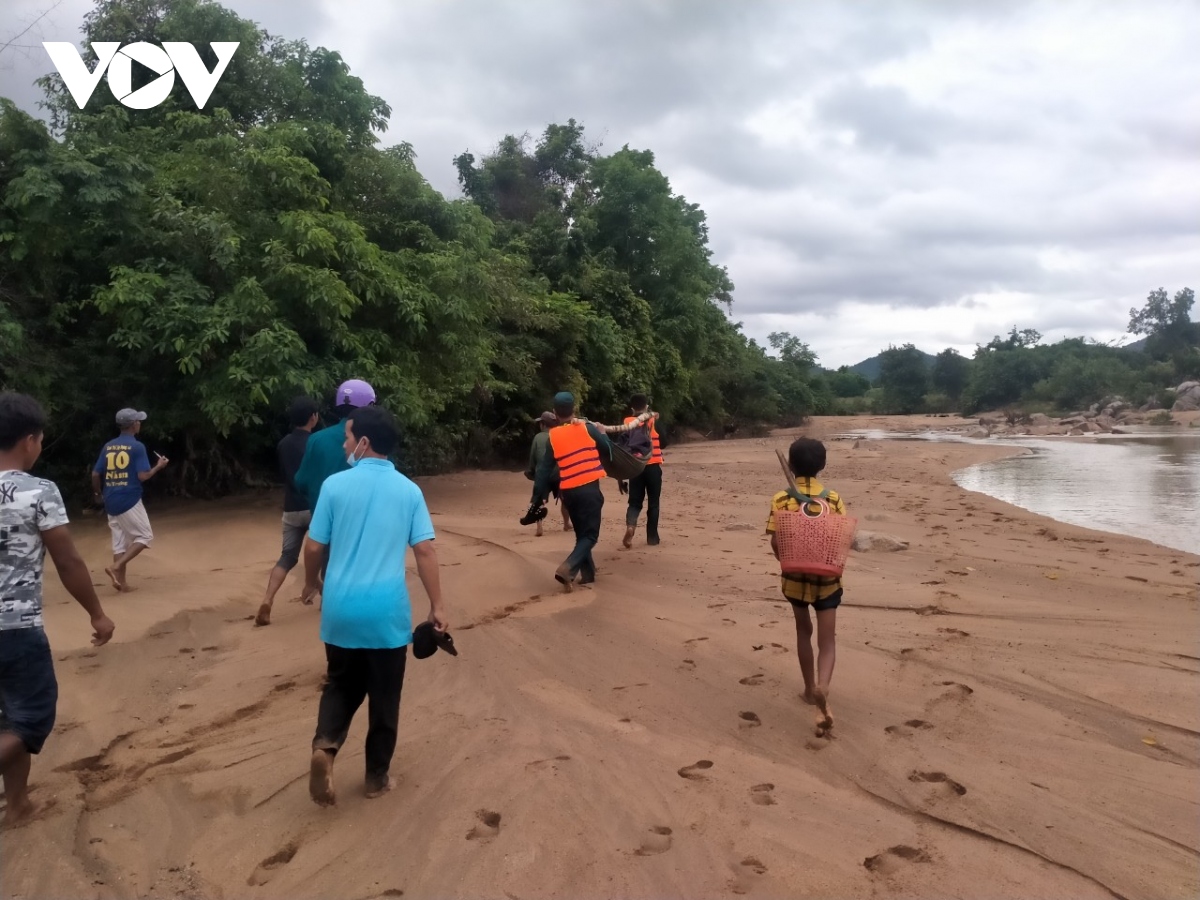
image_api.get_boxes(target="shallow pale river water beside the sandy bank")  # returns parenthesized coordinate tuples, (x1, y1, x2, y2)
(954, 434, 1200, 553)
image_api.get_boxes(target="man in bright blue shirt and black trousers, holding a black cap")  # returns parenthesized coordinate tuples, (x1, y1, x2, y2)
(304, 407, 449, 806)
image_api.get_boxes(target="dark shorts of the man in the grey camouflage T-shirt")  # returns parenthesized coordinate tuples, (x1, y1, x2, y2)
(0, 628, 59, 754)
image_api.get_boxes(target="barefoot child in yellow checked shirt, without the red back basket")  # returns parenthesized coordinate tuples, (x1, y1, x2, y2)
(767, 438, 846, 736)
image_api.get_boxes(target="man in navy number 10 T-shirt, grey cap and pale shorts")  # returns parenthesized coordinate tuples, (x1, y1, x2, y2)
(91, 408, 169, 592)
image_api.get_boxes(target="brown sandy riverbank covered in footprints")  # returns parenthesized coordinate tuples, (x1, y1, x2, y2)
(0, 418, 1200, 900)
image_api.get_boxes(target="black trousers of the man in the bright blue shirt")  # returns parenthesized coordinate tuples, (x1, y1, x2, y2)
(312, 643, 408, 788)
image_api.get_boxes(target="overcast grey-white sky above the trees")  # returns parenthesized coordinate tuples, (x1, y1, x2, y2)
(0, 0, 1200, 366)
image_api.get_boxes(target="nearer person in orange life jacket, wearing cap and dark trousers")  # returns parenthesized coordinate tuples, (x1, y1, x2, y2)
(533, 391, 612, 590)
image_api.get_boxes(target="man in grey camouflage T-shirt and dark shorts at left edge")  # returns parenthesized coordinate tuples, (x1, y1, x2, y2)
(0, 392, 114, 828)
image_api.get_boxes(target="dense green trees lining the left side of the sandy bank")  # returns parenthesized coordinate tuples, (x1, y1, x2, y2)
(0, 0, 835, 494)
